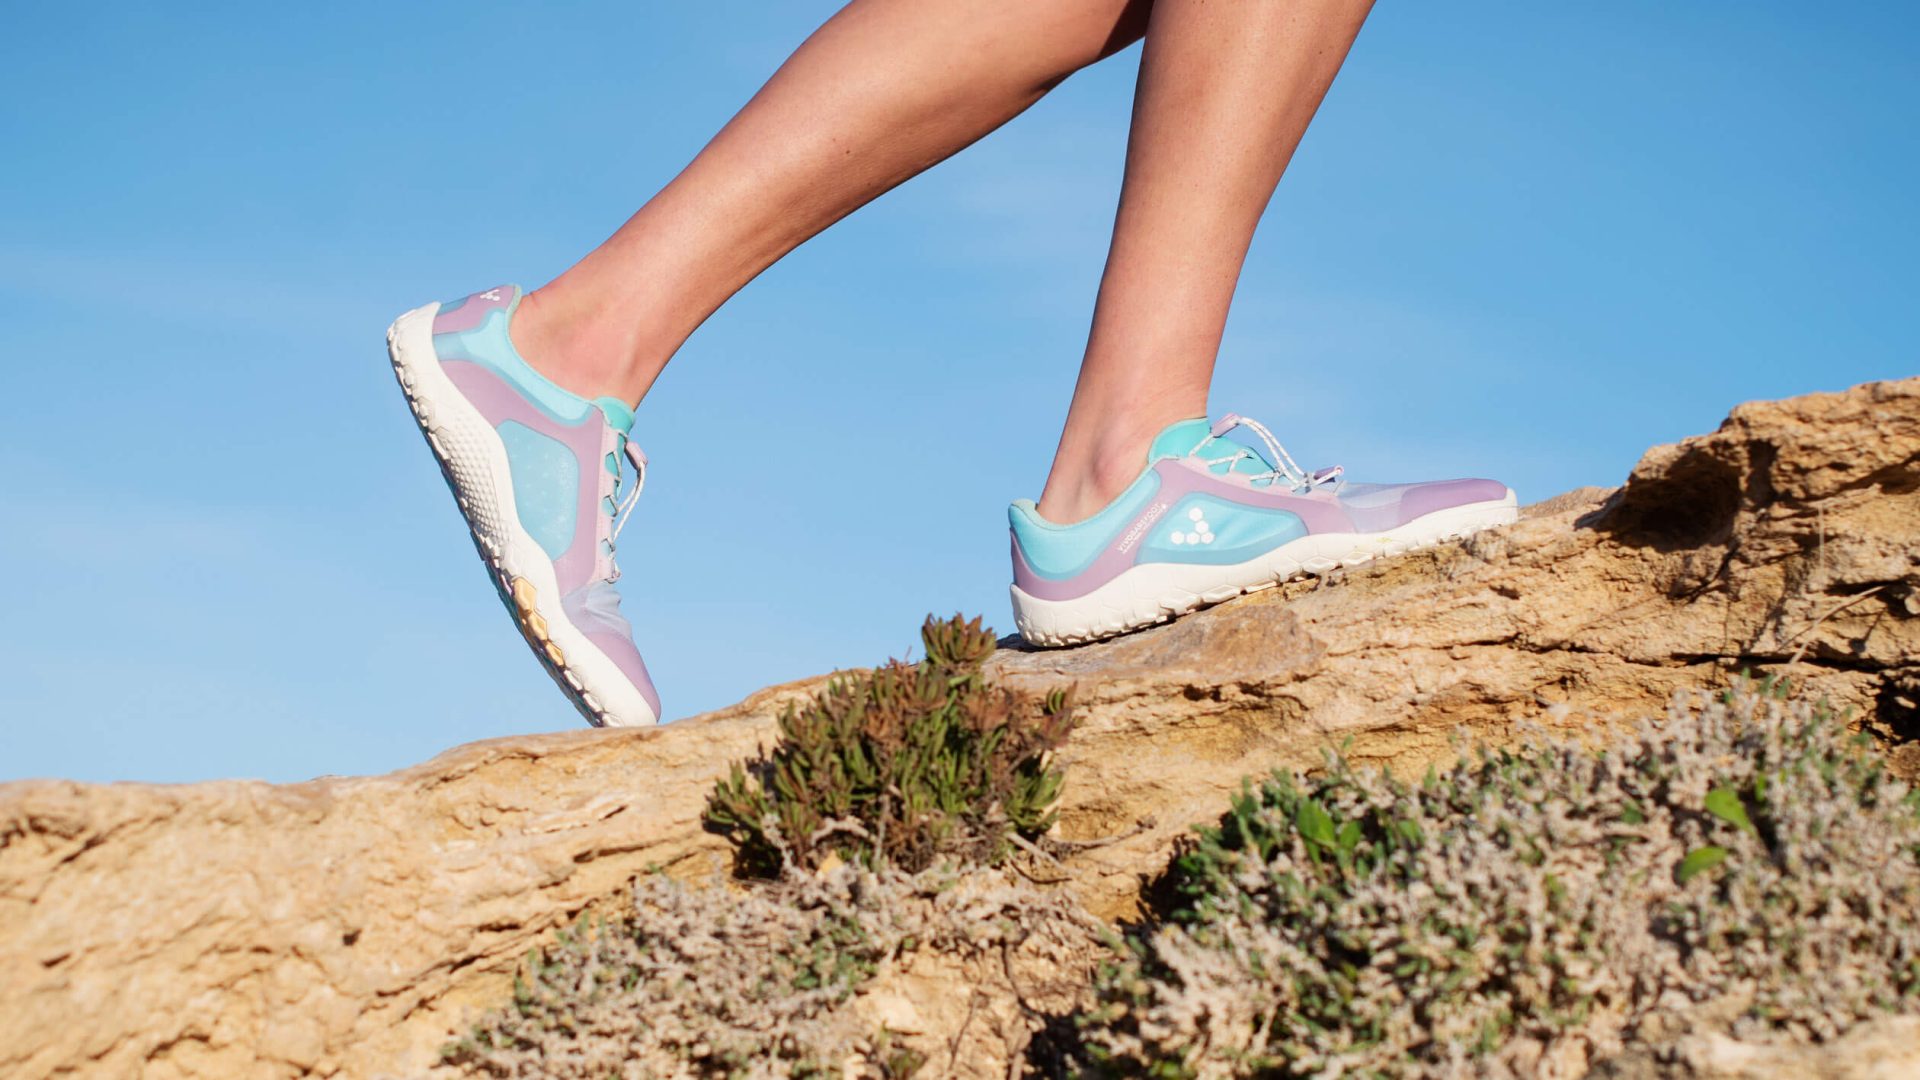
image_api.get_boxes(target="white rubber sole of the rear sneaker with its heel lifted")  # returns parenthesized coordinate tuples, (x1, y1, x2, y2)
(386, 304, 659, 726)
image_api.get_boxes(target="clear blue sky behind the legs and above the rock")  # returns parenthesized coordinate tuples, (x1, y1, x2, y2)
(0, 0, 1920, 780)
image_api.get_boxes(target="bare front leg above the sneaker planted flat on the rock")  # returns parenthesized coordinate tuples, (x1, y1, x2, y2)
(1039, 0, 1373, 523)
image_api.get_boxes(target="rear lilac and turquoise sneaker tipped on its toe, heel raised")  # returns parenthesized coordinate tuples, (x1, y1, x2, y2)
(386, 284, 660, 726)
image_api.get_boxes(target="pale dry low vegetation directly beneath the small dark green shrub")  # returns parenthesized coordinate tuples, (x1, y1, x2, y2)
(444, 863, 1089, 1080)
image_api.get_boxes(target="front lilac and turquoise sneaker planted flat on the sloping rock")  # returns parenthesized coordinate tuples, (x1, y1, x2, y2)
(1008, 413, 1519, 646)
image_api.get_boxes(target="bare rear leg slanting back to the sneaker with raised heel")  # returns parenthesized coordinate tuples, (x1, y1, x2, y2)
(513, 0, 1144, 402)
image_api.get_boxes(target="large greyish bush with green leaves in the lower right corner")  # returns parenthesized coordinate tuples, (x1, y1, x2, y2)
(1083, 688, 1920, 1076)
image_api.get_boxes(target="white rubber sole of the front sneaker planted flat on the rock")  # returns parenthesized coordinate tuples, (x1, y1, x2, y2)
(1014, 490, 1521, 646)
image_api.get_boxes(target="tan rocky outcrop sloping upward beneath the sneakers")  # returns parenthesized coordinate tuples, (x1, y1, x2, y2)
(0, 379, 1920, 1076)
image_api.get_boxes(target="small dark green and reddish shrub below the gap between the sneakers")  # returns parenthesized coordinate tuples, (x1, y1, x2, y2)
(707, 615, 1073, 876)
